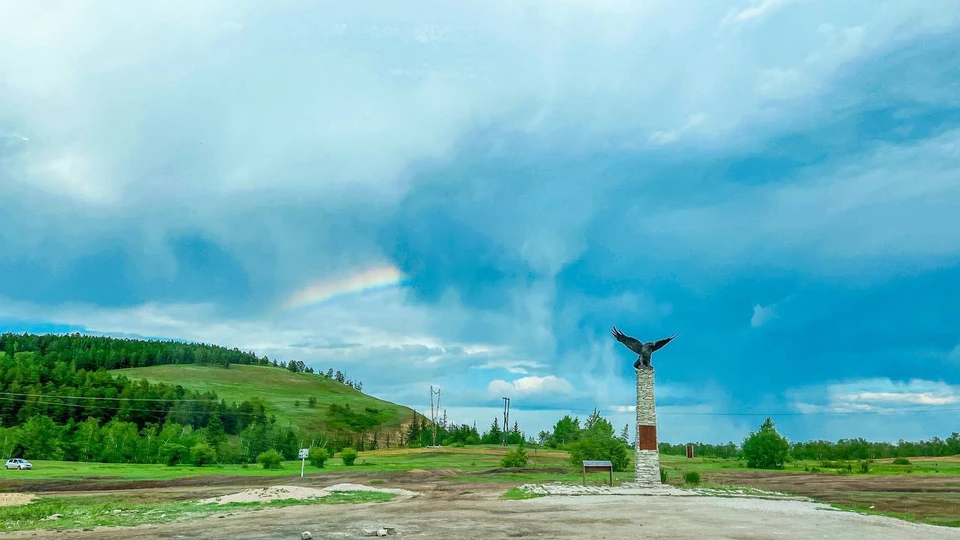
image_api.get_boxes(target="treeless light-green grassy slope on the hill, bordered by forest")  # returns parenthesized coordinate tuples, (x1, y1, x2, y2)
(113, 364, 413, 430)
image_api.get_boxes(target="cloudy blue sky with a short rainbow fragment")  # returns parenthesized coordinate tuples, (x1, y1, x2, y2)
(0, 0, 960, 443)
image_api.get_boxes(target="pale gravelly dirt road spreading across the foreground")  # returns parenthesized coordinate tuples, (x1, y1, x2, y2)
(0, 484, 960, 540)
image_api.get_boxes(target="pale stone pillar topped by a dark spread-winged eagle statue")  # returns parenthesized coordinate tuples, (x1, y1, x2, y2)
(613, 327, 679, 487)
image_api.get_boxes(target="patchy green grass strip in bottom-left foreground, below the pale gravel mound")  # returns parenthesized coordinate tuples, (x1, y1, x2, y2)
(0, 492, 395, 531)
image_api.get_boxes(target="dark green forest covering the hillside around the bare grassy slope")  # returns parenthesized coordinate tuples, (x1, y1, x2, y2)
(0, 334, 412, 463)
